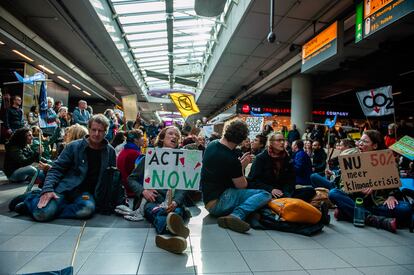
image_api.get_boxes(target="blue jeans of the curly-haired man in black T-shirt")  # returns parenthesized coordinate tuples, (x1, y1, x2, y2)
(208, 188, 272, 220)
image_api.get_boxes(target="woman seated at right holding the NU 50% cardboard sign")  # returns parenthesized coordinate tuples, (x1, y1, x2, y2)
(329, 130, 412, 232)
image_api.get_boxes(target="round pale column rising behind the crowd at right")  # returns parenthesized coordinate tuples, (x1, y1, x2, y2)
(291, 75, 313, 135)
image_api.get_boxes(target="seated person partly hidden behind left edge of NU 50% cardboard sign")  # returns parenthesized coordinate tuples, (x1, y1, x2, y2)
(310, 138, 359, 190)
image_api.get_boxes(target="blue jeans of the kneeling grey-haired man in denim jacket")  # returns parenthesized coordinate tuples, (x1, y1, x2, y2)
(24, 192, 95, 222)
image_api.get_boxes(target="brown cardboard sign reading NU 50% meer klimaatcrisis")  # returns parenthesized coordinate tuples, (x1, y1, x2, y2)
(339, 150, 401, 192)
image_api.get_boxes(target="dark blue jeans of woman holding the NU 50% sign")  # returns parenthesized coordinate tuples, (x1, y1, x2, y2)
(329, 188, 413, 226)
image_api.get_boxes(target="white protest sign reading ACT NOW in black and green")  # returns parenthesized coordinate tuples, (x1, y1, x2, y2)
(144, 148, 202, 190)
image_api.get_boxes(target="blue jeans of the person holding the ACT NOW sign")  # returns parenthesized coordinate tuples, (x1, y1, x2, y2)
(144, 202, 185, 234)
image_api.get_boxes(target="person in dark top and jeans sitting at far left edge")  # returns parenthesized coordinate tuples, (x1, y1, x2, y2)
(4, 128, 43, 182)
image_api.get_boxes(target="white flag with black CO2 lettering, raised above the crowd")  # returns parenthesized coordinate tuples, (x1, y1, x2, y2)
(357, 86, 394, 116)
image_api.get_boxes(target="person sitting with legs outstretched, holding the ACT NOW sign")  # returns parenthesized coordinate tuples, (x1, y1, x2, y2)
(128, 126, 190, 253)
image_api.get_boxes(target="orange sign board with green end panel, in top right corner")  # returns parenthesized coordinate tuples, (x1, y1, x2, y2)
(355, 0, 414, 42)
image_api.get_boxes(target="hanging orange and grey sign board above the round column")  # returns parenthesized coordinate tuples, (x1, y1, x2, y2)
(301, 21, 342, 73)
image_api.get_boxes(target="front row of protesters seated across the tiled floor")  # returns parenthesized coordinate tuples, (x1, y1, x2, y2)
(6, 114, 412, 253)
